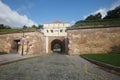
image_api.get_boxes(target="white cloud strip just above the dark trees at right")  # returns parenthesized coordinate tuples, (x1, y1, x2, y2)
(84, 0, 120, 19)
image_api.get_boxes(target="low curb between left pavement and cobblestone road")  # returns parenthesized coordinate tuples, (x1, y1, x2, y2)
(0, 55, 41, 66)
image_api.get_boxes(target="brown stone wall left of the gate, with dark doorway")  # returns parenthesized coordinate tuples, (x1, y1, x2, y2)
(0, 31, 45, 54)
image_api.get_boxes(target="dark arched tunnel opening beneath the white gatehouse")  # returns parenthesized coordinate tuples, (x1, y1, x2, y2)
(51, 39, 65, 53)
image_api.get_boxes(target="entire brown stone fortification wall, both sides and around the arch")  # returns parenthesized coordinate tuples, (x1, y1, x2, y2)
(0, 27, 120, 55)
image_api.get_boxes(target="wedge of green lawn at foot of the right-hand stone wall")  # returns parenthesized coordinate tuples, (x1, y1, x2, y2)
(81, 53, 120, 67)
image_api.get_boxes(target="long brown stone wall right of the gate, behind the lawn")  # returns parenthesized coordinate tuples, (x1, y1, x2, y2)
(68, 27, 120, 55)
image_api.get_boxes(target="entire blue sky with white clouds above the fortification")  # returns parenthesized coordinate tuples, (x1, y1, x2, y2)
(0, 0, 120, 27)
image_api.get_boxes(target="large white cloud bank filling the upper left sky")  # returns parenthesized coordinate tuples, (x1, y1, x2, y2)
(0, 0, 37, 27)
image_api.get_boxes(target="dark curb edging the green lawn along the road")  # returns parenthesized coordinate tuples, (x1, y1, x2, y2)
(80, 56, 120, 75)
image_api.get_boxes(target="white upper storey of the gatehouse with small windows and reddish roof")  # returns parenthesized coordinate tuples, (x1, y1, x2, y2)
(43, 21, 70, 36)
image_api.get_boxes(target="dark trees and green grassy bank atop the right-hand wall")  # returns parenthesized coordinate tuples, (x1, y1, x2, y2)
(74, 6, 120, 27)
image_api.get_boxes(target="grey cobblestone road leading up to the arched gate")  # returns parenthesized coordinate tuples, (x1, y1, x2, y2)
(0, 54, 120, 80)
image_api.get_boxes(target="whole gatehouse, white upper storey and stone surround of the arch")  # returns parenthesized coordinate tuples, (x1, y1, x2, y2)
(43, 21, 70, 53)
